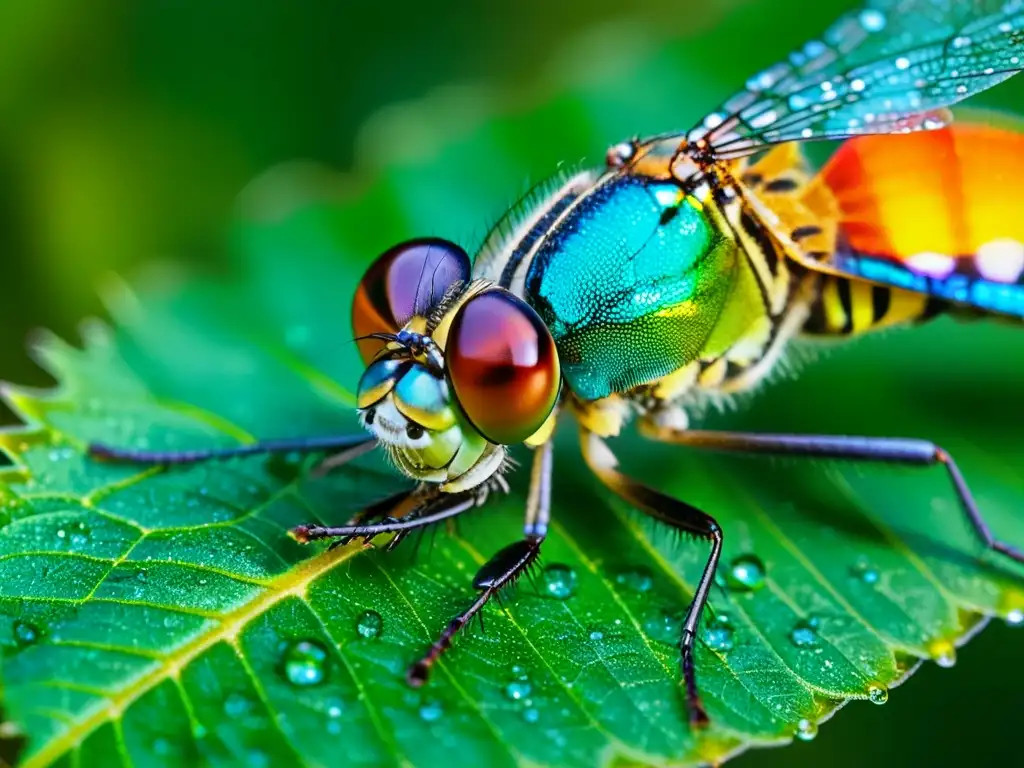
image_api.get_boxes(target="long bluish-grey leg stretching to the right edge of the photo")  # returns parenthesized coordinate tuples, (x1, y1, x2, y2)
(640, 423, 1024, 563)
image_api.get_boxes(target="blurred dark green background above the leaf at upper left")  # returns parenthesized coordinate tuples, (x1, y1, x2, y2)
(0, 0, 739, 409)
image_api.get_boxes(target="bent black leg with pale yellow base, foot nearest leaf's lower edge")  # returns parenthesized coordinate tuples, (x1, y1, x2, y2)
(580, 430, 722, 727)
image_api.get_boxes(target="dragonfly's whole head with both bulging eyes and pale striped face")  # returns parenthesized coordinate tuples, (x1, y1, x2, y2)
(352, 239, 561, 490)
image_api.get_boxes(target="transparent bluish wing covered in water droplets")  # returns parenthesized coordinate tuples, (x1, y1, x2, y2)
(687, 0, 1024, 159)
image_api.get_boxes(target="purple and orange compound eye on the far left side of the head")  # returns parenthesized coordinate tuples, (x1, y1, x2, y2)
(352, 238, 470, 365)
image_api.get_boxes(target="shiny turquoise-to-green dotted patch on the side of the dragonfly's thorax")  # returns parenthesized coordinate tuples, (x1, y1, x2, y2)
(524, 175, 737, 399)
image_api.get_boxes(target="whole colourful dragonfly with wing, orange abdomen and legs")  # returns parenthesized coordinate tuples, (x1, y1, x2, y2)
(91, 0, 1024, 727)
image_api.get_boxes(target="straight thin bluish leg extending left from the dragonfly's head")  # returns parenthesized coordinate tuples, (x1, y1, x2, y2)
(88, 433, 376, 464)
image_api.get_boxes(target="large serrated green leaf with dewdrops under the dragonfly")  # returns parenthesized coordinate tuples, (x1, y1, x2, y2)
(0, 18, 1024, 766)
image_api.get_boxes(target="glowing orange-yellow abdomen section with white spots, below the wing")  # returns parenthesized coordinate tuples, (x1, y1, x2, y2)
(822, 123, 1024, 284)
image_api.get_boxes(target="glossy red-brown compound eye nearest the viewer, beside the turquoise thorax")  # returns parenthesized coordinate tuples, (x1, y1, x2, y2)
(444, 290, 561, 445)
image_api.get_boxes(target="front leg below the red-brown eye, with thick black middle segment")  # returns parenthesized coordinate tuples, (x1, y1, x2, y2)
(406, 440, 552, 687)
